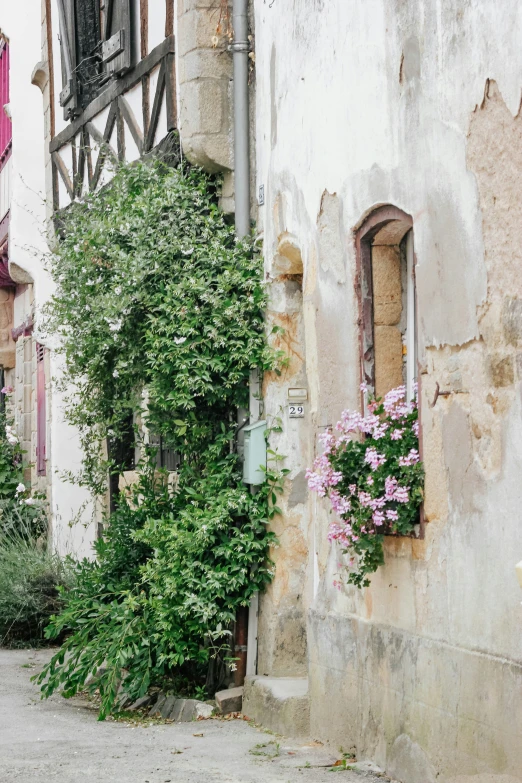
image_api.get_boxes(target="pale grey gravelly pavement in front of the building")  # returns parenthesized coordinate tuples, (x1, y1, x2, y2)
(0, 650, 383, 783)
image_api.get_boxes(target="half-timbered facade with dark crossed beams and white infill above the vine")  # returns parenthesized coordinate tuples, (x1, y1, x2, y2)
(49, 0, 177, 210)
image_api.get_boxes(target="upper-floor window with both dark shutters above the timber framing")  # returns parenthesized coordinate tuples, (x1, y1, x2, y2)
(58, 0, 133, 119)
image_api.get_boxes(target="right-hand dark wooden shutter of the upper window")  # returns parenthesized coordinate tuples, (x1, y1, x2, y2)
(101, 0, 133, 79)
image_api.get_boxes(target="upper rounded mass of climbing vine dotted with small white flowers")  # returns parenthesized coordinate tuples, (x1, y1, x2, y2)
(47, 155, 275, 494)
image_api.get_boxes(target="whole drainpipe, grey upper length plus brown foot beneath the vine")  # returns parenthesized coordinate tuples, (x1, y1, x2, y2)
(230, 0, 250, 686)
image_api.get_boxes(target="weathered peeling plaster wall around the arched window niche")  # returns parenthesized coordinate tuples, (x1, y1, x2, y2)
(255, 0, 522, 783)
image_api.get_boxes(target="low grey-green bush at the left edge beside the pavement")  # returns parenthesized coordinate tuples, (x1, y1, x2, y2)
(0, 524, 67, 646)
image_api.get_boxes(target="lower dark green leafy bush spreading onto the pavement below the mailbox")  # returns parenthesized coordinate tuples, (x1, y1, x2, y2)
(39, 455, 274, 718)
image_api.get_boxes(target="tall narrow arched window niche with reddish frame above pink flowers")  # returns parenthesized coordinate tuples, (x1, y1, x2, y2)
(355, 206, 417, 399)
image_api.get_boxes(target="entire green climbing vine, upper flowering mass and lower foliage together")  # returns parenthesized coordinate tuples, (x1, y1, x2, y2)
(39, 152, 283, 717)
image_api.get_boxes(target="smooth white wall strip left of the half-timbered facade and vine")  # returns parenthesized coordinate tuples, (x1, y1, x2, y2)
(0, 0, 95, 556)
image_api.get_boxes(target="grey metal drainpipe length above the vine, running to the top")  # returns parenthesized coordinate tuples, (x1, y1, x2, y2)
(230, 0, 250, 239)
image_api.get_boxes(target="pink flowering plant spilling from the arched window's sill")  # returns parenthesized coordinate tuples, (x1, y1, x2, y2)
(307, 384, 424, 587)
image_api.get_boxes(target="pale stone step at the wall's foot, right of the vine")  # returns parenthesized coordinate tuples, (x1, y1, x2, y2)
(243, 675, 310, 738)
